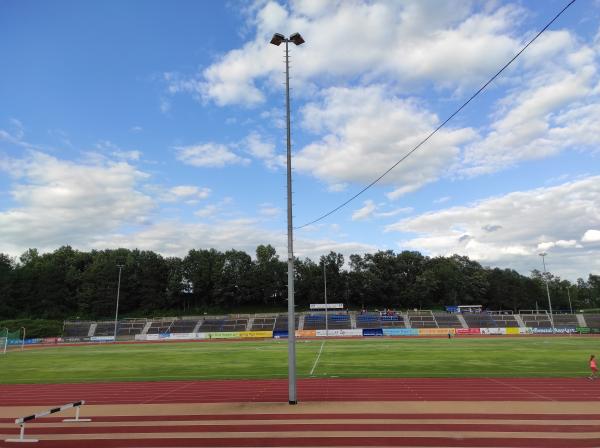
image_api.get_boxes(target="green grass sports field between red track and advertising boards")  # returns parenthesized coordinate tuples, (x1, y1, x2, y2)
(0, 336, 600, 384)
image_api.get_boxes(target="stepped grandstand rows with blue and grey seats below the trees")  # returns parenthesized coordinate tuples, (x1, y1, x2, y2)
(57, 310, 600, 340)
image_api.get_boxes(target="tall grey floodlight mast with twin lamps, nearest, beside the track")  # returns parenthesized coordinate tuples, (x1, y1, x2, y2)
(271, 29, 304, 404)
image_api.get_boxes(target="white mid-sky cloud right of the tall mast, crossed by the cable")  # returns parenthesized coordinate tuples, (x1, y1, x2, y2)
(294, 85, 474, 199)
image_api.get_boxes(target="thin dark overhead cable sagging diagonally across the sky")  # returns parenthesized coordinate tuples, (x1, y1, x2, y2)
(295, 0, 576, 229)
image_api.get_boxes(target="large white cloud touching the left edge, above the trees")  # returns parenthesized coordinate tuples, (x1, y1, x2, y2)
(0, 152, 154, 253)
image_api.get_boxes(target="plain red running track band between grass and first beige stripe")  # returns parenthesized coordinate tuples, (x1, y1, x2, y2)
(0, 378, 600, 406)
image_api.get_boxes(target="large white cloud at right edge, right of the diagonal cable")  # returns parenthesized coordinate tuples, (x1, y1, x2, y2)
(457, 35, 600, 175)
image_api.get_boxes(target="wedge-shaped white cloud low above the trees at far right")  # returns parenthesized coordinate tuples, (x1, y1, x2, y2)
(386, 176, 600, 279)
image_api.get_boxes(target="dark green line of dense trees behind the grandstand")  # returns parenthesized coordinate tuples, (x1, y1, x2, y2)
(0, 245, 600, 320)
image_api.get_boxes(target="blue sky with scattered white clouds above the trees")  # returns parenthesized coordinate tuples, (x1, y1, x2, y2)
(0, 0, 600, 280)
